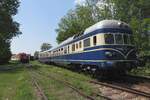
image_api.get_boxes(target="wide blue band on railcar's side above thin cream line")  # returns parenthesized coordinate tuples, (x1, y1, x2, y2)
(52, 50, 134, 61)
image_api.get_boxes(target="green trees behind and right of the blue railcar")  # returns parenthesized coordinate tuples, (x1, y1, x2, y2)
(56, 0, 150, 55)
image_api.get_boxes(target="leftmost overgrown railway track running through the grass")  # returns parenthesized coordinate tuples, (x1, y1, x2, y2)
(29, 71, 48, 100)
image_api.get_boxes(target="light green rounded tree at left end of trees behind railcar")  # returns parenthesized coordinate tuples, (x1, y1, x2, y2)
(56, 5, 95, 43)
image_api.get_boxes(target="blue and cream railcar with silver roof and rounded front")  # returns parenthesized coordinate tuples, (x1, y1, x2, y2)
(40, 20, 137, 74)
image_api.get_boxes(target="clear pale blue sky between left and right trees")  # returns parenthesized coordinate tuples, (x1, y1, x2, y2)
(11, 0, 82, 54)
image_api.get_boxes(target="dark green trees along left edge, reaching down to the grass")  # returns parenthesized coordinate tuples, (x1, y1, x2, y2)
(0, 0, 21, 64)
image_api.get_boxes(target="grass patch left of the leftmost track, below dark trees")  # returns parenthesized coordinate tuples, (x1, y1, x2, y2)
(0, 62, 36, 100)
